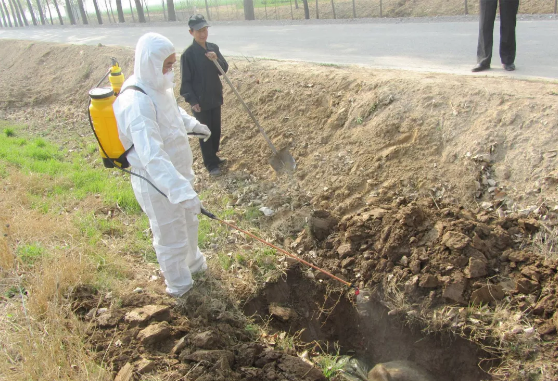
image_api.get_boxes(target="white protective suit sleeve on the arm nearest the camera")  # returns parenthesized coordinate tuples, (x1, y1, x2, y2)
(126, 95, 197, 204)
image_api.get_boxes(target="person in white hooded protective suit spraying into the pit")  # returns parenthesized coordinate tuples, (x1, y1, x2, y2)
(113, 33, 211, 297)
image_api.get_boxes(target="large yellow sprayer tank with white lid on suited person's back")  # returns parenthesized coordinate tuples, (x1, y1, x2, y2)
(89, 88, 126, 168)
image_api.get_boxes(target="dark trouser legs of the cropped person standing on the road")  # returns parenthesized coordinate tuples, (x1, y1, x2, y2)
(477, 0, 519, 66)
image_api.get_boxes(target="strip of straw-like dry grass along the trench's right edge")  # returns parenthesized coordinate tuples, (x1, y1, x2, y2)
(381, 278, 558, 381)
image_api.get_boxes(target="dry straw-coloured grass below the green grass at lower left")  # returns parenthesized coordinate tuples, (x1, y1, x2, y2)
(0, 165, 135, 381)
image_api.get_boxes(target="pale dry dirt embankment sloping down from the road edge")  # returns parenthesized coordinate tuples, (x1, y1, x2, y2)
(0, 41, 558, 218)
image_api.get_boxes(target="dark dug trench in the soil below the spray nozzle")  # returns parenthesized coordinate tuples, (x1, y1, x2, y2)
(244, 268, 497, 381)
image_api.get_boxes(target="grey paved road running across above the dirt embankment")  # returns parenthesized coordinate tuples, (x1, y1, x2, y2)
(0, 17, 558, 80)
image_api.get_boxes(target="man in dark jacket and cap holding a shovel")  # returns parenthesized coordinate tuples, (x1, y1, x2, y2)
(180, 14, 229, 176)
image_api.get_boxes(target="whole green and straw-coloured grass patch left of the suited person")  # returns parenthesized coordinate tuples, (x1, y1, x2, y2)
(0, 121, 144, 381)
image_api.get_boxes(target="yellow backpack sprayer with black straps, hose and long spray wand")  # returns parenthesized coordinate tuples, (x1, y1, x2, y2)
(88, 58, 359, 295)
